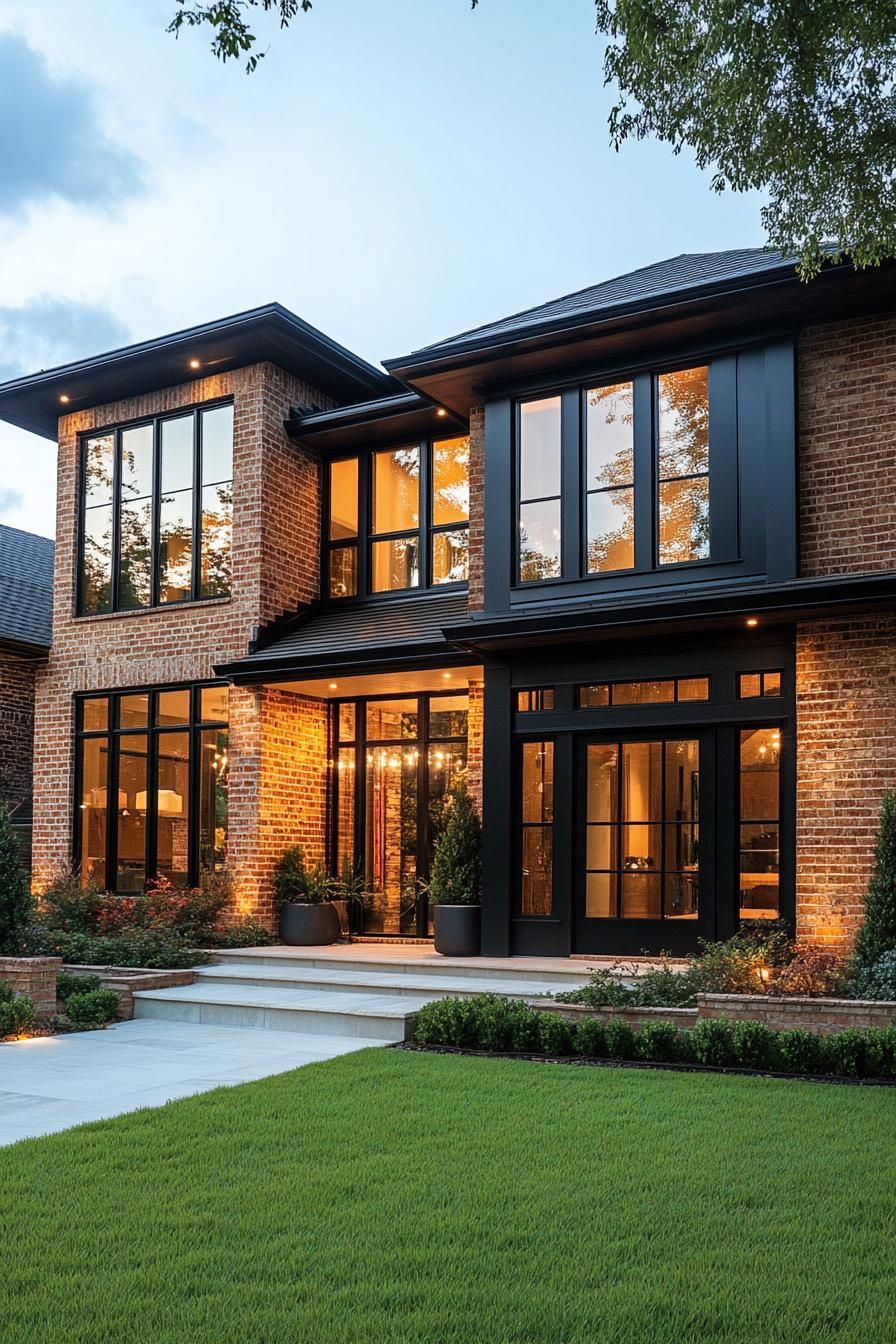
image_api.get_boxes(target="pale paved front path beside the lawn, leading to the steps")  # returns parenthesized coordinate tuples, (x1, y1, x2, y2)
(0, 1020, 386, 1145)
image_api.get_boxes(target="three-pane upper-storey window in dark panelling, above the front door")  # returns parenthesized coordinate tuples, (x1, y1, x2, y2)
(517, 364, 712, 583)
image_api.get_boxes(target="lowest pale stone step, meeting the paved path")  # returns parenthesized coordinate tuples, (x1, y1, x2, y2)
(134, 980, 429, 1044)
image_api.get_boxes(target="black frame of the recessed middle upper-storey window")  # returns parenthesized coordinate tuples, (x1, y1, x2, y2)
(321, 433, 470, 603)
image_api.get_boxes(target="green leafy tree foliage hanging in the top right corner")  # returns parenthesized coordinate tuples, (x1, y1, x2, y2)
(595, 0, 896, 278)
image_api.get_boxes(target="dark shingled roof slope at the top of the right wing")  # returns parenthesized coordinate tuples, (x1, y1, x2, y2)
(402, 247, 797, 367)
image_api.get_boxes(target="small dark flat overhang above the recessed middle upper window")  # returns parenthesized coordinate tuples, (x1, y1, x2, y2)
(285, 391, 469, 456)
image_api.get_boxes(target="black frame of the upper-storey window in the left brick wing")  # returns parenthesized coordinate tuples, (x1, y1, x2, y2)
(74, 396, 234, 620)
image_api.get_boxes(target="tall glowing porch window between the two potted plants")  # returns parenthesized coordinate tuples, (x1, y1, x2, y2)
(330, 691, 469, 935)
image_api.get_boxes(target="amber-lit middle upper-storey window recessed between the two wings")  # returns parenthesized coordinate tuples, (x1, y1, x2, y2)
(324, 438, 470, 598)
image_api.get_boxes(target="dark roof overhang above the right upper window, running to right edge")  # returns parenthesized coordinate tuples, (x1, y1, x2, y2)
(383, 262, 896, 414)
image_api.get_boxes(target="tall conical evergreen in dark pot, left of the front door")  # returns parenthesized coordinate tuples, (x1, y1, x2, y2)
(430, 784, 482, 957)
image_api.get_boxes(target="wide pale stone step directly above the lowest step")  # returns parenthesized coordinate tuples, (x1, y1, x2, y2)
(196, 961, 587, 999)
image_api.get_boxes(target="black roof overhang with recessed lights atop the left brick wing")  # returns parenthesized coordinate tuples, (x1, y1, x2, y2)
(0, 304, 402, 439)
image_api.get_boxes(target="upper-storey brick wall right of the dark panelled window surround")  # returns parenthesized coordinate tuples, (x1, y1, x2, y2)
(797, 317, 896, 575)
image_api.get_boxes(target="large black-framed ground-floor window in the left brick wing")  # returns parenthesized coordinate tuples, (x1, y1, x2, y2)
(75, 685, 228, 892)
